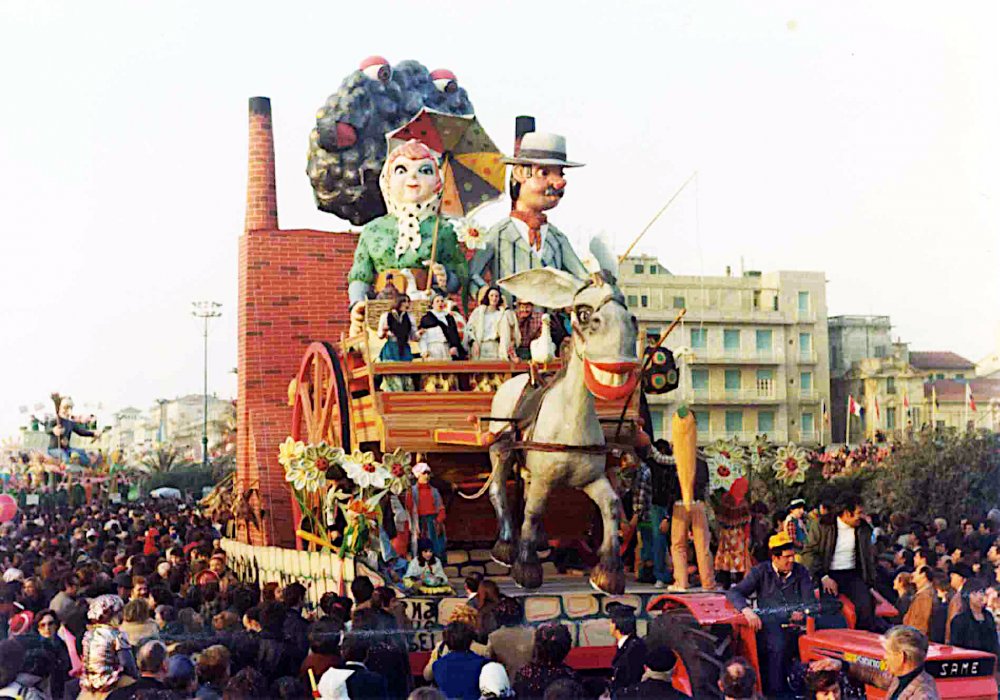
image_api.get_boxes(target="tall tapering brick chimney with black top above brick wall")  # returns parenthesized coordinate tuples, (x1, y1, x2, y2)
(244, 97, 278, 231)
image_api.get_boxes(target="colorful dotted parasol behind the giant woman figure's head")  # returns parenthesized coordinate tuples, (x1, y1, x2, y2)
(386, 107, 506, 216)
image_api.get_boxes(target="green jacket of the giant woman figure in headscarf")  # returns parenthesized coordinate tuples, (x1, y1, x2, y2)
(347, 214, 469, 304)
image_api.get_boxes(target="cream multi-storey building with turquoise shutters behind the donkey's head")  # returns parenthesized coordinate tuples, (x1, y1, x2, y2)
(618, 255, 830, 444)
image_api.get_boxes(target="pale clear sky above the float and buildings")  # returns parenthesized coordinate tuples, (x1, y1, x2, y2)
(0, 0, 1000, 435)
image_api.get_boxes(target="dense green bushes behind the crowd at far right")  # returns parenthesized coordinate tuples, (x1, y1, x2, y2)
(865, 430, 1000, 522)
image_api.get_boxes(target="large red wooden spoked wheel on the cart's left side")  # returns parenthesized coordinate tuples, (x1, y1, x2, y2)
(292, 342, 351, 548)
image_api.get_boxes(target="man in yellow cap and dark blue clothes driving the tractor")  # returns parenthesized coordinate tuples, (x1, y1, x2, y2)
(726, 530, 816, 698)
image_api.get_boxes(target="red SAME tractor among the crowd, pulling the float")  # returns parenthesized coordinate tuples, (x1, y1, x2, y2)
(647, 593, 997, 700)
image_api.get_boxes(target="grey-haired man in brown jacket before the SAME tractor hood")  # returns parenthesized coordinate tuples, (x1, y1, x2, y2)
(810, 625, 941, 700)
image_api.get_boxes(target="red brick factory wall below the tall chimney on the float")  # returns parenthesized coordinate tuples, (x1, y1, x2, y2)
(236, 230, 358, 546)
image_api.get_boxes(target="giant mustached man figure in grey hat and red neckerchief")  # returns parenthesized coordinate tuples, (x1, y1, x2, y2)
(469, 117, 589, 306)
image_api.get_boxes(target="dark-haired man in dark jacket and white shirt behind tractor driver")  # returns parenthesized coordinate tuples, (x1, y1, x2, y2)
(802, 493, 881, 631)
